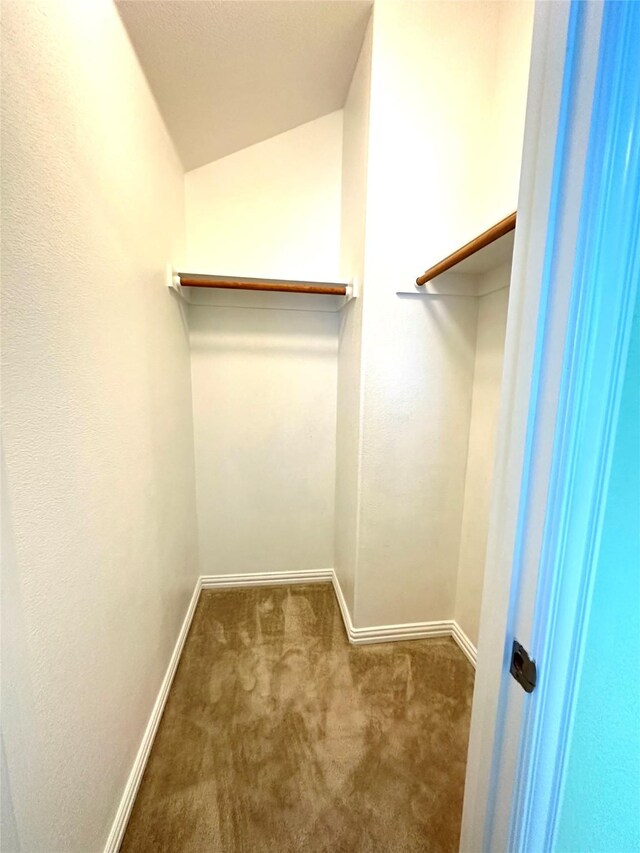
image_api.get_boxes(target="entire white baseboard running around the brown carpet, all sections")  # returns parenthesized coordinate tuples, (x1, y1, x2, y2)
(104, 569, 476, 853)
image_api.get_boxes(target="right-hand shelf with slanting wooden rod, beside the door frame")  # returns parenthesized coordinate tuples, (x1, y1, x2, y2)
(396, 213, 516, 296)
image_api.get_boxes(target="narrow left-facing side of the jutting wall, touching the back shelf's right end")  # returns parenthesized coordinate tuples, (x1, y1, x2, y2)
(334, 22, 372, 618)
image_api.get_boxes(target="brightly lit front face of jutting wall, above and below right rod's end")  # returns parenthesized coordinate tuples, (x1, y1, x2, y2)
(355, 0, 531, 626)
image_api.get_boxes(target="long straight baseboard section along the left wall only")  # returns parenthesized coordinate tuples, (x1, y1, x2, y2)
(104, 578, 201, 853)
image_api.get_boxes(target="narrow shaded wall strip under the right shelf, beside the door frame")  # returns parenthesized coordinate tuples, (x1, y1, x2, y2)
(455, 262, 511, 646)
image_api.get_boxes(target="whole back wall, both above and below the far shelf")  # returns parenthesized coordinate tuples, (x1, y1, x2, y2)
(186, 112, 342, 574)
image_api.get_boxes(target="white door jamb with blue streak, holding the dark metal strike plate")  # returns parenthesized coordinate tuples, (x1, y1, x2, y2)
(460, 2, 632, 853)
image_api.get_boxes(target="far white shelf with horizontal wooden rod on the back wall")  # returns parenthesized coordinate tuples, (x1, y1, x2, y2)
(167, 269, 356, 308)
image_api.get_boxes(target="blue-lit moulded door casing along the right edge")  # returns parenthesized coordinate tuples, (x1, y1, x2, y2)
(508, 2, 640, 851)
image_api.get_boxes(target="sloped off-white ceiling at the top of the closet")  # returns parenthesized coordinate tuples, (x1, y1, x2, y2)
(116, 0, 371, 171)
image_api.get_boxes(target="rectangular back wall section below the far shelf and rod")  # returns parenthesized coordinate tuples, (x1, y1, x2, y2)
(189, 306, 338, 574)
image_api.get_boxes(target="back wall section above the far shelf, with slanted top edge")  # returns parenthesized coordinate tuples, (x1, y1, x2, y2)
(185, 110, 342, 281)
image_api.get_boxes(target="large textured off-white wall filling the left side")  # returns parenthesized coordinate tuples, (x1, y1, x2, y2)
(2, 0, 197, 853)
